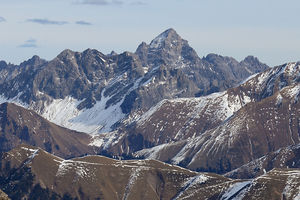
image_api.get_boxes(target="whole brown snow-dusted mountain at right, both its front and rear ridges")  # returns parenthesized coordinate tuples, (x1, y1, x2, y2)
(119, 63, 300, 173)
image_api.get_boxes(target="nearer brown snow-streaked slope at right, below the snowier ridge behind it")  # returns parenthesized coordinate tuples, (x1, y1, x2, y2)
(137, 83, 300, 172)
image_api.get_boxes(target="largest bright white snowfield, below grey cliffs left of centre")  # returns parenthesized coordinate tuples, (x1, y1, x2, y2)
(41, 90, 125, 134)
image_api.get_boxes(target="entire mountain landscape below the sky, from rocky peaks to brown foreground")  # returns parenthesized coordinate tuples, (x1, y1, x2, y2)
(0, 29, 300, 200)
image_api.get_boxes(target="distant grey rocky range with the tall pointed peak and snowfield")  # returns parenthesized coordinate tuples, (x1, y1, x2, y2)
(0, 29, 268, 134)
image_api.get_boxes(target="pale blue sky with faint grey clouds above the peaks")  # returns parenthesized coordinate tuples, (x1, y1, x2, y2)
(0, 0, 300, 66)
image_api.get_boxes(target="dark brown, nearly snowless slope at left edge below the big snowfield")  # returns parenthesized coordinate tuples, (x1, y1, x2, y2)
(0, 103, 97, 158)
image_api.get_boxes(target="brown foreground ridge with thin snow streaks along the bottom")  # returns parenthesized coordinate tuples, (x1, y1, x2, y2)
(0, 145, 300, 200)
